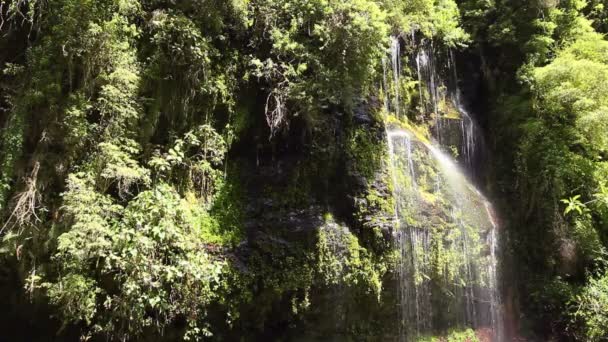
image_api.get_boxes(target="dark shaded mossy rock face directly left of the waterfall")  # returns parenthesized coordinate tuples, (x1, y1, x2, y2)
(216, 101, 398, 341)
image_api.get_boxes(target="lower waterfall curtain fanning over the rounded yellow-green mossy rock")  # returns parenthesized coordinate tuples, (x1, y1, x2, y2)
(388, 130, 502, 341)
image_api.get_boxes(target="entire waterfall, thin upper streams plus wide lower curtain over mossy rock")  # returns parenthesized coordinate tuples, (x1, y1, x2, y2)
(384, 34, 503, 342)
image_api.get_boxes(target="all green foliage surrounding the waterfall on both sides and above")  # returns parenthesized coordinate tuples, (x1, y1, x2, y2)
(0, 0, 608, 341)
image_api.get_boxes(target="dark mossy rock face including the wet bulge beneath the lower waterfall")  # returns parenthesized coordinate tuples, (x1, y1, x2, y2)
(209, 103, 498, 341)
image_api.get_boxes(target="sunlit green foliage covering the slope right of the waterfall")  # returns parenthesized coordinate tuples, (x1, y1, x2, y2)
(461, 0, 608, 341)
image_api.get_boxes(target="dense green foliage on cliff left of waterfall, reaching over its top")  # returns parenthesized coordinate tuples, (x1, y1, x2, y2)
(0, 0, 467, 341)
